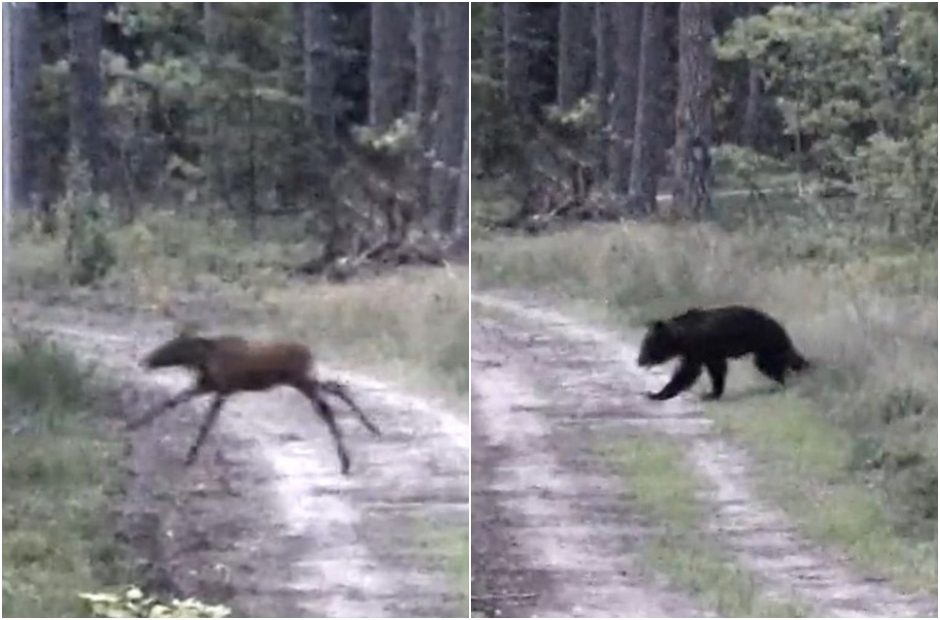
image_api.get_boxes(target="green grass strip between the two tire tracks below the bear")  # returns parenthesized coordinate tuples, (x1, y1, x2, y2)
(600, 437, 805, 618)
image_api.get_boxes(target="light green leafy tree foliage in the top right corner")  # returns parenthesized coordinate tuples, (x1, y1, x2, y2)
(716, 3, 937, 242)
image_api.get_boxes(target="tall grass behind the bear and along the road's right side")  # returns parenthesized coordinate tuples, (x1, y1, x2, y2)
(472, 209, 937, 592)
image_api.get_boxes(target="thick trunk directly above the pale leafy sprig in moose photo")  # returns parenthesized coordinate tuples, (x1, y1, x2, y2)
(369, 2, 408, 127)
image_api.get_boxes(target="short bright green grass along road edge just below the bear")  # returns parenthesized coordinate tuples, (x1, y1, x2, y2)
(707, 392, 937, 593)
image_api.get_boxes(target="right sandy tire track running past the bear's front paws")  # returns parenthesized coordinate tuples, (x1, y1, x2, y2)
(474, 293, 937, 617)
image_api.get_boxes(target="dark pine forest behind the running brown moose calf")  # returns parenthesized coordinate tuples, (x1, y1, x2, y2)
(4, 3, 469, 280)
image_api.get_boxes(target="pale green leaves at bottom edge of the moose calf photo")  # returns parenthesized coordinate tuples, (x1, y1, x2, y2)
(79, 587, 232, 618)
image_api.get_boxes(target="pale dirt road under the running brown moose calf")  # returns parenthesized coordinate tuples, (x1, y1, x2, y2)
(15, 306, 469, 617)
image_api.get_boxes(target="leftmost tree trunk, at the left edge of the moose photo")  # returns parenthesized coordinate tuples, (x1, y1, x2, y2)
(4, 2, 41, 207)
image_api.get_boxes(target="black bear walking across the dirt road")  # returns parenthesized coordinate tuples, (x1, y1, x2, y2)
(637, 306, 809, 400)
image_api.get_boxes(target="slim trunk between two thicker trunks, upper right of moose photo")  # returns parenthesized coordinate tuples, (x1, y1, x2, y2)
(414, 2, 440, 219)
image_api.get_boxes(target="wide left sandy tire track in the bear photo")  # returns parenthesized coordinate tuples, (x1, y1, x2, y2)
(472, 318, 698, 617)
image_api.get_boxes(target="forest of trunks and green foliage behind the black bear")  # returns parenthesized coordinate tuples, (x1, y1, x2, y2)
(472, 3, 937, 242)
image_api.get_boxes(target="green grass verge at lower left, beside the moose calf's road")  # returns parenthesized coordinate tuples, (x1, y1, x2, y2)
(3, 337, 129, 617)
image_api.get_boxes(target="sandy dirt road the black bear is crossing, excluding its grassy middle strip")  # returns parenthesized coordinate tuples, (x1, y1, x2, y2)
(472, 293, 936, 617)
